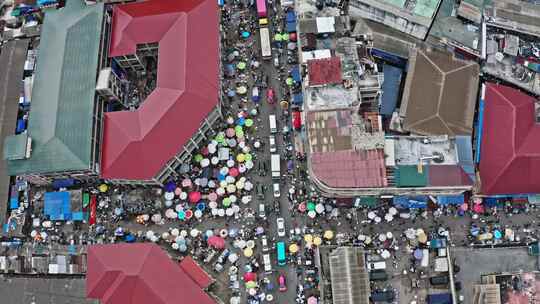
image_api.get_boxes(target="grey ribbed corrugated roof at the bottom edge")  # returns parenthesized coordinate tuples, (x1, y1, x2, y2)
(328, 247, 371, 304)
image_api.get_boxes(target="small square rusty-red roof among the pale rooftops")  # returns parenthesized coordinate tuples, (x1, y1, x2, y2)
(308, 57, 341, 86)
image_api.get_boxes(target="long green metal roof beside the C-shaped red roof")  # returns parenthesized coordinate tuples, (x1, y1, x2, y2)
(8, 0, 103, 175)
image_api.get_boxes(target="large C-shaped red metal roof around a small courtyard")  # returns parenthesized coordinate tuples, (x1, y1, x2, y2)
(101, 0, 219, 180)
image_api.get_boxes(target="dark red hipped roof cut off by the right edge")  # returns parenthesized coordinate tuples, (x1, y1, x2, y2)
(480, 84, 540, 195)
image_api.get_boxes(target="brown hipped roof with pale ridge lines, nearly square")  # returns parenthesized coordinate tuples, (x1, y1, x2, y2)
(401, 50, 479, 136)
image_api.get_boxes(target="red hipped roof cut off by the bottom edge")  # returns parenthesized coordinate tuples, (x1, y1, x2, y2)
(86, 243, 216, 304)
